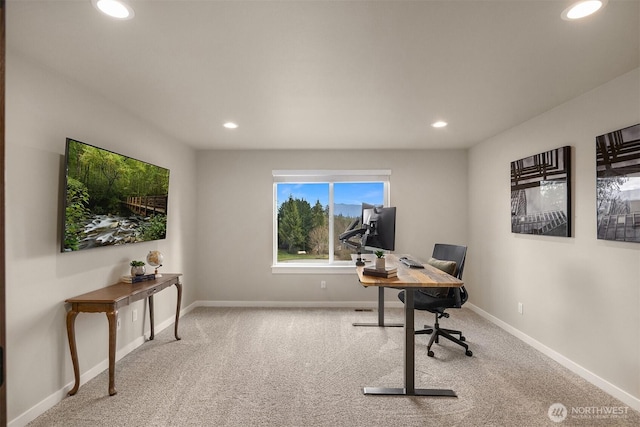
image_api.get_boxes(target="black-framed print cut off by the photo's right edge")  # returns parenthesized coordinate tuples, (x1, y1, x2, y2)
(596, 124, 640, 243)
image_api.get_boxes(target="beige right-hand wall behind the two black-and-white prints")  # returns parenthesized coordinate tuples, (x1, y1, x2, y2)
(465, 69, 640, 409)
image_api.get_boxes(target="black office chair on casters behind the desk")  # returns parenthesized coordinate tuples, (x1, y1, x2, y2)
(398, 243, 473, 357)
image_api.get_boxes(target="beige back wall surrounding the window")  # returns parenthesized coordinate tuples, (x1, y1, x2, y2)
(192, 150, 467, 305)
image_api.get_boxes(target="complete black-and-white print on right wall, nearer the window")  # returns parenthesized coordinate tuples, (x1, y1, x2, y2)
(511, 146, 571, 237)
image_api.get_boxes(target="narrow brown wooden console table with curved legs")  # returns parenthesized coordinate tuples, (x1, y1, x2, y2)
(65, 273, 182, 396)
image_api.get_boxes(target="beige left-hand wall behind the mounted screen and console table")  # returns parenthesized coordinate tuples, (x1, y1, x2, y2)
(6, 52, 196, 421)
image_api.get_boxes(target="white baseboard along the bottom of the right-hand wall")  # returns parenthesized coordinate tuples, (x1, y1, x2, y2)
(465, 302, 640, 411)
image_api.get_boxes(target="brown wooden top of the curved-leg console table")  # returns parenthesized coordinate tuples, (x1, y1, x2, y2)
(65, 273, 182, 305)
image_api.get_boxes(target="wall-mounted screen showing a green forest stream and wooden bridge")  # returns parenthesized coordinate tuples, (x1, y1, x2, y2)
(62, 138, 169, 252)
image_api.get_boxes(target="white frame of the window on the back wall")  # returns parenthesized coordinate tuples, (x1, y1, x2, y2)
(271, 169, 391, 274)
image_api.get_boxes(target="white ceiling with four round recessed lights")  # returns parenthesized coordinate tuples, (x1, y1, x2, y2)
(7, 0, 640, 149)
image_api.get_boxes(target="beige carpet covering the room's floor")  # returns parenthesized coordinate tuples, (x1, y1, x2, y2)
(29, 308, 640, 427)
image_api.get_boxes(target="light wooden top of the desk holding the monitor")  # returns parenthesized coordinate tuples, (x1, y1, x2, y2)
(356, 254, 464, 288)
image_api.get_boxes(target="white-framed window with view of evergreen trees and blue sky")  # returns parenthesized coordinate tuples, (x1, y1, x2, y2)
(273, 170, 391, 273)
